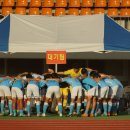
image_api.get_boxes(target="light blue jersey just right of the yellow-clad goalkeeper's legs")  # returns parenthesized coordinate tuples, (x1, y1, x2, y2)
(62, 77, 82, 88)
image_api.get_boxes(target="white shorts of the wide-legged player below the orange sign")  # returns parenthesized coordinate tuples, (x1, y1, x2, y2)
(46, 86, 61, 98)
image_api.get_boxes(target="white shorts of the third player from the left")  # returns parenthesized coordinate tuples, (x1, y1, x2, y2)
(27, 84, 40, 98)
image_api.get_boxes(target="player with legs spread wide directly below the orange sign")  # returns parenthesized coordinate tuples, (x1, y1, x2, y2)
(42, 73, 62, 117)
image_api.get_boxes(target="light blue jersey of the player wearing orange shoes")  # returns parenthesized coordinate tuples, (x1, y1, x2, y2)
(82, 77, 98, 90)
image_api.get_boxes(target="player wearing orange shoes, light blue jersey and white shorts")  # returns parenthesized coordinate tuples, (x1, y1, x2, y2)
(81, 69, 100, 117)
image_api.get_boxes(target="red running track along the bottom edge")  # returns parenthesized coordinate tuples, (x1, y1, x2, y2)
(0, 119, 130, 130)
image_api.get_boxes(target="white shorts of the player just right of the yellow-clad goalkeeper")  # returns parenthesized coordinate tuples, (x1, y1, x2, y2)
(71, 86, 82, 99)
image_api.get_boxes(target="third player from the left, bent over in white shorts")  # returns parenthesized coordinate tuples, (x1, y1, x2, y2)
(26, 74, 45, 117)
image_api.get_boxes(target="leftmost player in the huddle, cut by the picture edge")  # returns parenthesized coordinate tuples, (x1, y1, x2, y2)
(0, 76, 13, 116)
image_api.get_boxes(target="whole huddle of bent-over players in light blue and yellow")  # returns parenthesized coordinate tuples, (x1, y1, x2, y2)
(0, 67, 123, 117)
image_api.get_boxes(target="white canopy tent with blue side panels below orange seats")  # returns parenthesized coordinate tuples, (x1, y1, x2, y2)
(0, 14, 130, 53)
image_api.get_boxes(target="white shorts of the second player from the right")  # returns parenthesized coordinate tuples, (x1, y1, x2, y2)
(99, 86, 109, 99)
